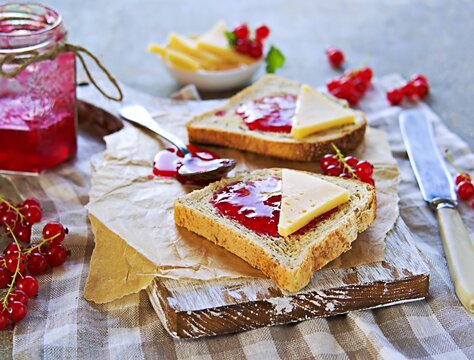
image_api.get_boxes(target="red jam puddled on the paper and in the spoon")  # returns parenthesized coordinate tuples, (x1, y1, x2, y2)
(153, 145, 219, 183)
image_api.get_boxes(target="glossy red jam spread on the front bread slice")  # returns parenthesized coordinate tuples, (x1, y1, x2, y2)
(211, 177, 337, 237)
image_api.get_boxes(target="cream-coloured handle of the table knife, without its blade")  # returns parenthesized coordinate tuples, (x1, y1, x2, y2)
(436, 206, 474, 313)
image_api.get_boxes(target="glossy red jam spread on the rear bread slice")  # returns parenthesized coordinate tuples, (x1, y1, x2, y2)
(236, 95, 296, 133)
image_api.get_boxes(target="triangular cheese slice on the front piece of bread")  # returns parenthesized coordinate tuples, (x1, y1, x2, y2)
(278, 169, 349, 236)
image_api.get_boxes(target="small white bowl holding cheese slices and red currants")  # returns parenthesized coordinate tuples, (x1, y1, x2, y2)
(165, 60, 262, 91)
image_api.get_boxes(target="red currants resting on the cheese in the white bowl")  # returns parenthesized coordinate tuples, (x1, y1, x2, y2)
(227, 24, 270, 59)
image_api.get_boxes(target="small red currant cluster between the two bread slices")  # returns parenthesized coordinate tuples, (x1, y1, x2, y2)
(319, 145, 375, 185)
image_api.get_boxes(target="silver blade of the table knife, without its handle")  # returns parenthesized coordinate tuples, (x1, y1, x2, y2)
(400, 109, 457, 205)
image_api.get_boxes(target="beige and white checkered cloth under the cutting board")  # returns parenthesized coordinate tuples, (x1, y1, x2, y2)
(0, 76, 474, 359)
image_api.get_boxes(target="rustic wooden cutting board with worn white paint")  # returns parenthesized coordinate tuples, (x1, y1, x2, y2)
(147, 218, 429, 338)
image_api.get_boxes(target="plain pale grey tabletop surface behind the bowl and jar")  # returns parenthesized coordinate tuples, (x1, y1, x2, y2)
(0, 0, 474, 359)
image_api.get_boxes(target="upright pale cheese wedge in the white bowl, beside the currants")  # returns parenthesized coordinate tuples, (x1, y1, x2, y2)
(197, 21, 255, 65)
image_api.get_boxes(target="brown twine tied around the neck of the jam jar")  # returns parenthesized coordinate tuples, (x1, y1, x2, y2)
(0, 42, 123, 101)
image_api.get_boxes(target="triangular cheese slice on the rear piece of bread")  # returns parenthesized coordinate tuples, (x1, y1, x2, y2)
(291, 85, 356, 139)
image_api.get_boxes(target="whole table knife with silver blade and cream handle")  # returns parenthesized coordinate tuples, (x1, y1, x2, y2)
(400, 109, 474, 313)
